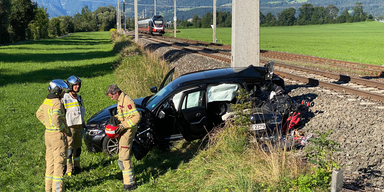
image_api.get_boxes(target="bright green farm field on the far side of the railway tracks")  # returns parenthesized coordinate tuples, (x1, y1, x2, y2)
(171, 22, 384, 65)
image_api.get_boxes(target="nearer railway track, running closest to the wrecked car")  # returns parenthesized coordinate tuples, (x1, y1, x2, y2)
(140, 33, 384, 103)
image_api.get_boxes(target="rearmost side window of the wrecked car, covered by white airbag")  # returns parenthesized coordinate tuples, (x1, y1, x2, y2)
(207, 83, 239, 103)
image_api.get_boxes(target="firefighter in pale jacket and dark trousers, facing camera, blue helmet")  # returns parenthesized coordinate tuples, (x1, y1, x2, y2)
(62, 75, 85, 177)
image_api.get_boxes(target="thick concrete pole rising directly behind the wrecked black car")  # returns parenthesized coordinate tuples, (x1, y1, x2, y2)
(231, 0, 260, 67)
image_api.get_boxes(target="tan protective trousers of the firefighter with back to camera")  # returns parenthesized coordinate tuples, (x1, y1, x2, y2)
(45, 131, 67, 192)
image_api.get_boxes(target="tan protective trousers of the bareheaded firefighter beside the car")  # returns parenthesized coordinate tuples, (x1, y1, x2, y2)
(118, 127, 137, 185)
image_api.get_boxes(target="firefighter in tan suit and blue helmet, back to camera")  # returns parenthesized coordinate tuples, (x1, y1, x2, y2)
(36, 79, 68, 192)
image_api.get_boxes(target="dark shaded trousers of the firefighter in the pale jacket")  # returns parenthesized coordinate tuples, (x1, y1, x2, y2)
(67, 125, 83, 173)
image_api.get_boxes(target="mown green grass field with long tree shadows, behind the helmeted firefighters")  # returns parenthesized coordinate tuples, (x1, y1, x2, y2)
(0, 32, 117, 191)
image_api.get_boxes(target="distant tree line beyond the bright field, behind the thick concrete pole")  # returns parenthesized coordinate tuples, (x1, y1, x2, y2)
(177, 2, 374, 28)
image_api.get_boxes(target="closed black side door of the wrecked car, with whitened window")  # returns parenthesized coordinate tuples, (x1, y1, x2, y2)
(176, 87, 209, 141)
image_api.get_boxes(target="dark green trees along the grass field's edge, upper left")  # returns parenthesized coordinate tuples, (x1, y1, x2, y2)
(0, 0, 116, 44)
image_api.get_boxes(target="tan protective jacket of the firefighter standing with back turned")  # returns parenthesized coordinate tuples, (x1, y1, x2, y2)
(36, 98, 68, 133)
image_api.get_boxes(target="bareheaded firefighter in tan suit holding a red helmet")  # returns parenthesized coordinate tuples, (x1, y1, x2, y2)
(106, 84, 140, 191)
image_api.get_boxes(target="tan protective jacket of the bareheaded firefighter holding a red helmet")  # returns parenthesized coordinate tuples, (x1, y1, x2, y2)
(116, 92, 140, 128)
